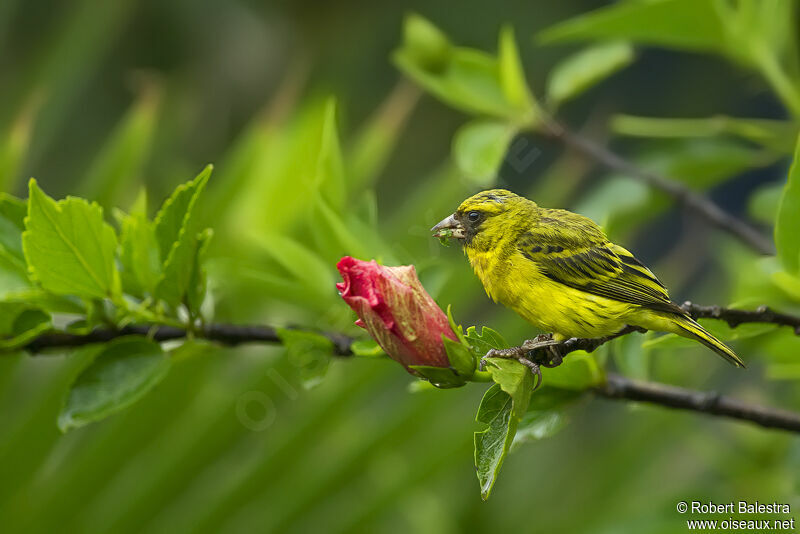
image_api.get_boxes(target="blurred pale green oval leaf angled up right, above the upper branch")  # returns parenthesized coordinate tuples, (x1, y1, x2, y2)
(547, 42, 634, 105)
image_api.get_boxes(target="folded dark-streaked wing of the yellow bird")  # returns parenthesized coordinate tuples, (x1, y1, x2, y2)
(518, 210, 683, 314)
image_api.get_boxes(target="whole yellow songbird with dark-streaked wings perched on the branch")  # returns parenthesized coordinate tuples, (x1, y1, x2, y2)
(431, 189, 744, 367)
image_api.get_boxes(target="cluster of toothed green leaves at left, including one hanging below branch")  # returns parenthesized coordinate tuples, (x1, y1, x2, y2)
(0, 171, 212, 430)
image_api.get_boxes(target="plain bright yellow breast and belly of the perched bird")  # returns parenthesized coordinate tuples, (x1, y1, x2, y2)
(466, 249, 639, 338)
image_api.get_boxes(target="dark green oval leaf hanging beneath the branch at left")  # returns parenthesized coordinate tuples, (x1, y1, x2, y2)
(58, 337, 171, 432)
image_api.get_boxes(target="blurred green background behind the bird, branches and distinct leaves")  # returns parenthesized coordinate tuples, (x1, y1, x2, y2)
(0, 0, 800, 533)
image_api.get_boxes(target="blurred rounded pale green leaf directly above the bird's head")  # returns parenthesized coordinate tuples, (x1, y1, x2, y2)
(453, 120, 516, 188)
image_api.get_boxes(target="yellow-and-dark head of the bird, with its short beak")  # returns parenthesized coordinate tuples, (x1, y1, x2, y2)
(431, 189, 537, 250)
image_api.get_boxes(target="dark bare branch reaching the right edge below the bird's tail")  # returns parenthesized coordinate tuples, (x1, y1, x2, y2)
(594, 374, 800, 432)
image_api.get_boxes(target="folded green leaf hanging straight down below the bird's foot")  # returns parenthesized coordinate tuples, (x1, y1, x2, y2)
(474, 358, 533, 500)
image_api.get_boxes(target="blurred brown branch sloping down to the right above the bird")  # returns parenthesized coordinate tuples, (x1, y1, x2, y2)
(543, 119, 775, 255)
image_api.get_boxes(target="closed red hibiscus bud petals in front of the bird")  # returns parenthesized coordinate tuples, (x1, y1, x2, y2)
(336, 256, 458, 370)
